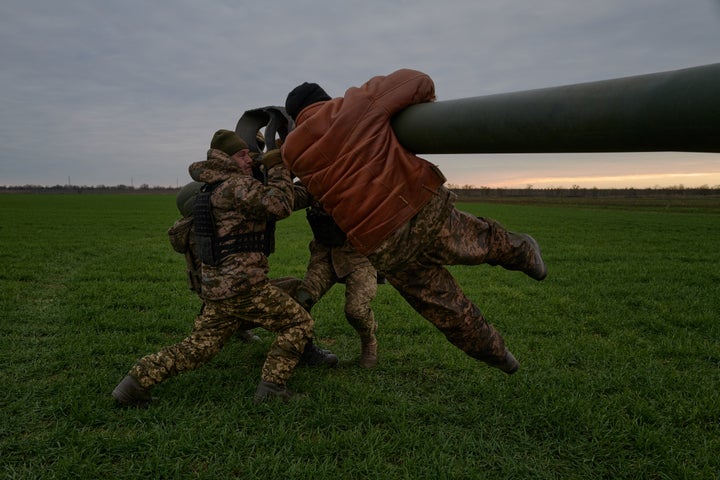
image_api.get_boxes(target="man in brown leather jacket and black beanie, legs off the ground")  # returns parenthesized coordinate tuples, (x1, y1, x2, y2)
(282, 69, 547, 374)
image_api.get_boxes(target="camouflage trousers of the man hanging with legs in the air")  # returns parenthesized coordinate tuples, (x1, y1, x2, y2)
(368, 188, 531, 364)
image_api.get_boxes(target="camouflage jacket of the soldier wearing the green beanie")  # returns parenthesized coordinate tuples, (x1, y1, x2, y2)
(188, 149, 293, 300)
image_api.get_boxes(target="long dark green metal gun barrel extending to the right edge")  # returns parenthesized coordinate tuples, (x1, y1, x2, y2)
(392, 63, 720, 154)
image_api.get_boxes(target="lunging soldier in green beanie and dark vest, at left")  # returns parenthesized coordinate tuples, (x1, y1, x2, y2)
(112, 130, 337, 407)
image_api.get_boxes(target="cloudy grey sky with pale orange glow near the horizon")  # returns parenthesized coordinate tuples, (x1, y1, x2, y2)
(0, 0, 720, 188)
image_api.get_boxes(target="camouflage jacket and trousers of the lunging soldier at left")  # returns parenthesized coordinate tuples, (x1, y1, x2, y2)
(129, 149, 313, 388)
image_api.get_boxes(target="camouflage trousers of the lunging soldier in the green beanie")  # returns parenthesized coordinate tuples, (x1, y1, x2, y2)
(129, 282, 313, 387)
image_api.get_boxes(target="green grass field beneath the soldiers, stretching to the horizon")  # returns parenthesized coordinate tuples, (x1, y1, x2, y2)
(0, 195, 720, 480)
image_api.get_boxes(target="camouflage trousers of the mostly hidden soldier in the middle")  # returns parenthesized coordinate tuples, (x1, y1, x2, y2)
(301, 250, 377, 338)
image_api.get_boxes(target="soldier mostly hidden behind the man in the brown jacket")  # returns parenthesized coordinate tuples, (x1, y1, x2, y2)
(295, 196, 378, 368)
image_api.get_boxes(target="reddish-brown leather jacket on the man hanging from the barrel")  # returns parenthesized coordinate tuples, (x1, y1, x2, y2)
(283, 69, 445, 255)
